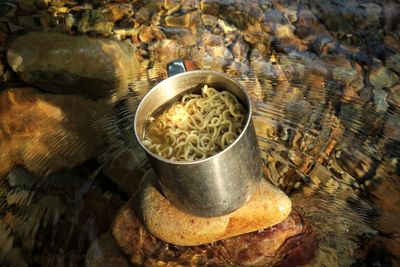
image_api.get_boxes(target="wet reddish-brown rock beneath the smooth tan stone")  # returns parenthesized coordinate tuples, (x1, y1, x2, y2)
(113, 203, 317, 266)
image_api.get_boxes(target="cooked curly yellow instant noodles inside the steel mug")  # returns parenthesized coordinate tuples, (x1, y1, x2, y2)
(143, 85, 246, 161)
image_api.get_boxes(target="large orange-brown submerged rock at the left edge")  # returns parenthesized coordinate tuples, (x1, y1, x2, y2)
(0, 88, 110, 177)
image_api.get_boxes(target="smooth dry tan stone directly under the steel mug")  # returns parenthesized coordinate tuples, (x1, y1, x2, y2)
(140, 176, 292, 246)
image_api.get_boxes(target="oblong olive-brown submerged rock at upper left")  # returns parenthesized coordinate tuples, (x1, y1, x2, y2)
(7, 32, 139, 99)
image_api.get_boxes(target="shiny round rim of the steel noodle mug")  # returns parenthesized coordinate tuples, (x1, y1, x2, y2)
(133, 70, 253, 165)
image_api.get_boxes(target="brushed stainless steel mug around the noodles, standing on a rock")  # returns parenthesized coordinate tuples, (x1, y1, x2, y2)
(134, 61, 262, 217)
